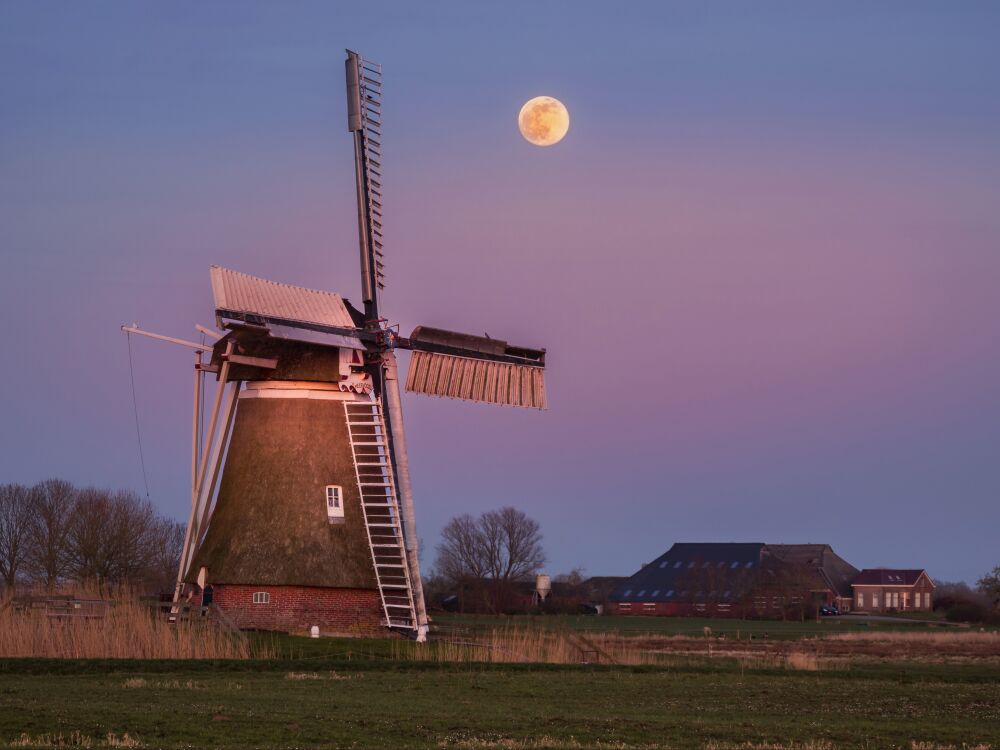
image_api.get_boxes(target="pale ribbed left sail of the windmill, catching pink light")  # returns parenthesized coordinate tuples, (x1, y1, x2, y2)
(211, 266, 355, 328)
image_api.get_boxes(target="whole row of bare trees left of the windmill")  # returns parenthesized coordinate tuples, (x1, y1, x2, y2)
(0, 479, 184, 591)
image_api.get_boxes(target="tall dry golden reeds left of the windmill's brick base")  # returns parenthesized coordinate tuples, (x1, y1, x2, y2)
(0, 594, 258, 659)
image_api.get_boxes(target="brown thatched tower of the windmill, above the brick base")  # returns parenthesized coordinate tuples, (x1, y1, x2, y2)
(188, 398, 375, 588)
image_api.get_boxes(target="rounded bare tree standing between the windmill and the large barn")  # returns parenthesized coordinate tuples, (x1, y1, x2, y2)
(436, 507, 545, 612)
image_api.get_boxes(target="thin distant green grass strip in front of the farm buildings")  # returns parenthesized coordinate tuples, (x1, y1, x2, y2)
(434, 614, 948, 639)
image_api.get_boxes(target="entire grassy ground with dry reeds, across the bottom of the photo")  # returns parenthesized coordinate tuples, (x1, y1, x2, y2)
(0, 610, 1000, 750)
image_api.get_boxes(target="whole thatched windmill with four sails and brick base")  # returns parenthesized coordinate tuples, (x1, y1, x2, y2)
(123, 51, 545, 640)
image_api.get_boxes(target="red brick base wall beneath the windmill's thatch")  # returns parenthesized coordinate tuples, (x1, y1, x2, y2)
(212, 583, 384, 634)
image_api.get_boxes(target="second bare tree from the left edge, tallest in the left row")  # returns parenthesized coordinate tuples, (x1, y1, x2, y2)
(27, 479, 76, 590)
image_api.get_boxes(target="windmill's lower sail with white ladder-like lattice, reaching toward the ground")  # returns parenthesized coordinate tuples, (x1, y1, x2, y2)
(344, 400, 417, 633)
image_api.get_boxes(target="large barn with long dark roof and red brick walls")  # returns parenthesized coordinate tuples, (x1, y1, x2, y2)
(609, 543, 858, 618)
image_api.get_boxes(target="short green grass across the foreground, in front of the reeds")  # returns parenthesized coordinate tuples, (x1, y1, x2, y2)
(0, 656, 1000, 748)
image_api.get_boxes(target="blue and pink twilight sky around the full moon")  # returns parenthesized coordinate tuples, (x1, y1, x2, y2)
(0, 0, 1000, 581)
